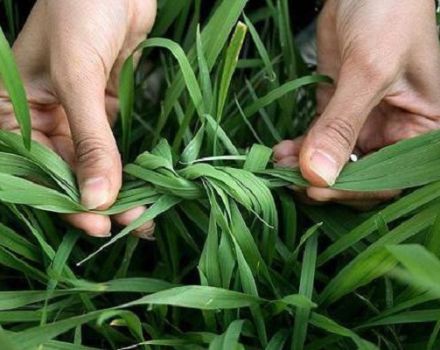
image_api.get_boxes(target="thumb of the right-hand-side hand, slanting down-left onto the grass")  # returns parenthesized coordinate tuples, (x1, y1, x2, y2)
(299, 72, 387, 187)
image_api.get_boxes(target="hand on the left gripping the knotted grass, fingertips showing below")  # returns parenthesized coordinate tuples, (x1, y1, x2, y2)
(0, 0, 156, 238)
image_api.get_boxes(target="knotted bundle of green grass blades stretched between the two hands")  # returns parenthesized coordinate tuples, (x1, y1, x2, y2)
(0, 127, 440, 264)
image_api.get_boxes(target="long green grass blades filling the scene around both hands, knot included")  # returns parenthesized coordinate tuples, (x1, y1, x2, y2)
(0, 0, 440, 350)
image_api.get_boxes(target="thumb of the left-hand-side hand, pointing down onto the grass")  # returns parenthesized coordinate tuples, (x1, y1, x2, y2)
(54, 58, 122, 210)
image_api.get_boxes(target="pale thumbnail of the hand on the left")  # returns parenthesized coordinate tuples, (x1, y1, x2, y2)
(81, 177, 110, 210)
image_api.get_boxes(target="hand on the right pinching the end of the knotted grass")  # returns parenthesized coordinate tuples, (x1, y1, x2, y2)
(274, 0, 440, 207)
